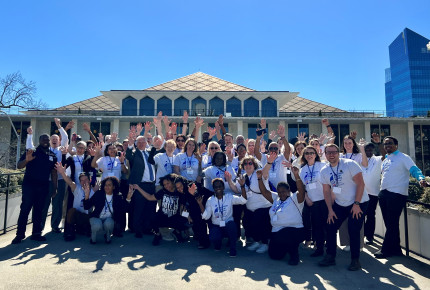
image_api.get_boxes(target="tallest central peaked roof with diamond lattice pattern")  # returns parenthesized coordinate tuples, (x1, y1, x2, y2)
(144, 72, 255, 92)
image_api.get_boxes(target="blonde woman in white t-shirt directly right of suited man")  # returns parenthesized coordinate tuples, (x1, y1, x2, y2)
(148, 139, 176, 191)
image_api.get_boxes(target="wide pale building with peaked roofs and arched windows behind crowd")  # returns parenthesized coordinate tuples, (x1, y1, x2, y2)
(0, 73, 430, 171)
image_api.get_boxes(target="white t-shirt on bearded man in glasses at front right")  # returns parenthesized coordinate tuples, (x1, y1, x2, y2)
(321, 158, 369, 206)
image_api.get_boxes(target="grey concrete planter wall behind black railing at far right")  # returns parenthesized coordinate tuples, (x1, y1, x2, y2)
(375, 205, 430, 259)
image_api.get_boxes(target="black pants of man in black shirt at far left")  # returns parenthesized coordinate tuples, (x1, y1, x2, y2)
(16, 182, 49, 237)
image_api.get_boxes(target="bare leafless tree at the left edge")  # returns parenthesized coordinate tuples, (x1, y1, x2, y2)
(0, 72, 47, 109)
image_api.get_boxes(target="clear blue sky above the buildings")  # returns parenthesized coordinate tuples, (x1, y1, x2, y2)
(0, 0, 430, 110)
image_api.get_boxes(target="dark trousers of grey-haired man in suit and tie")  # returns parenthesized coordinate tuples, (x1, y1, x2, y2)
(132, 182, 157, 234)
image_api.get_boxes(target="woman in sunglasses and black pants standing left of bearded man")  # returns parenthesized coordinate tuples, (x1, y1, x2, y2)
(300, 145, 328, 257)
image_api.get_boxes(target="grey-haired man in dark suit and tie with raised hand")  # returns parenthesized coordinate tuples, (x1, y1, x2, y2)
(125, 130, 157, 238)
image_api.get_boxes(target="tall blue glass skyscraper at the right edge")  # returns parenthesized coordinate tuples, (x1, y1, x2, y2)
(385, 28, 430, 117)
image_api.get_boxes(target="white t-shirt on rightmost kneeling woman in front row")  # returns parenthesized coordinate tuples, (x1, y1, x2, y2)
(269, 191, 304, 232)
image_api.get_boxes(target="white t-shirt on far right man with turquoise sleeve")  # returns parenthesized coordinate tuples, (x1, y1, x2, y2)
(381, 151, 416, 196)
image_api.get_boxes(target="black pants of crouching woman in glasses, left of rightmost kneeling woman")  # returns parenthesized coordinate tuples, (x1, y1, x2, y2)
(243, 207, 272, 244)
